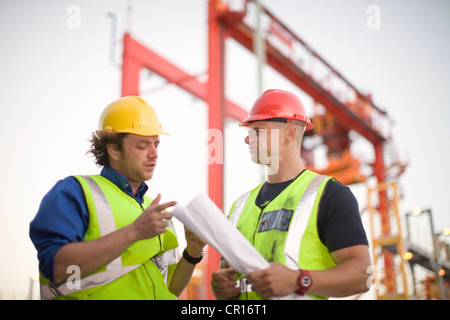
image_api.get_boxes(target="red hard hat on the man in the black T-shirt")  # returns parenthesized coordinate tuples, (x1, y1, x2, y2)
(240, 89, 314, 130)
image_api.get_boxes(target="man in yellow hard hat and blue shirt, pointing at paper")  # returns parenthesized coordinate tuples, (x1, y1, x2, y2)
(30, 96, 205, 300)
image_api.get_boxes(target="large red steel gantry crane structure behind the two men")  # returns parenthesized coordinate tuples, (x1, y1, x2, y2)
(118, 0, 436, 299)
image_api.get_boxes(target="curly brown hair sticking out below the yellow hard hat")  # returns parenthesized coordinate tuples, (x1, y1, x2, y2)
(87, 130, 128, 167)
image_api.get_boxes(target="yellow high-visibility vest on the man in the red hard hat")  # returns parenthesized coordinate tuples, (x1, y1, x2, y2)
(228, 170, 336, 300)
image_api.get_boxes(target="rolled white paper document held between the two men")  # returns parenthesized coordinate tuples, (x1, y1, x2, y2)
(172, 193, 269, 275)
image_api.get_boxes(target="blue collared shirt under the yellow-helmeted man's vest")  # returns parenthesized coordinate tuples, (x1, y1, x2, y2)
(30, 166, 148, 282)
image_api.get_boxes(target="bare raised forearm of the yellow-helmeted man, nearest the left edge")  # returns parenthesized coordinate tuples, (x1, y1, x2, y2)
(54, 226, 136, 283)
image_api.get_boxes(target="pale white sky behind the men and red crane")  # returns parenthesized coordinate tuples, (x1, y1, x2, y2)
(0, 0, 450, 293)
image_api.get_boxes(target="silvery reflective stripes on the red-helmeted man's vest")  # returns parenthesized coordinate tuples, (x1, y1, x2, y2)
(229, 174, 330, 300)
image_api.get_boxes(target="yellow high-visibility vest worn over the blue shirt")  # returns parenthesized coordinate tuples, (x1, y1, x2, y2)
(40, 175, 178, 300)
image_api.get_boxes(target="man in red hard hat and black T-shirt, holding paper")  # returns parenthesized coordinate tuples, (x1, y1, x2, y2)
(211, 90, 371, 299)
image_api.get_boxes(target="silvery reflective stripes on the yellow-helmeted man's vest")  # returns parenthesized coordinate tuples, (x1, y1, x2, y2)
(41, 176, 176, 300)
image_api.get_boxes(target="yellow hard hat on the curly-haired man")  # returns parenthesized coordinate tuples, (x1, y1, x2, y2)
(98, 96, 168, 136)
